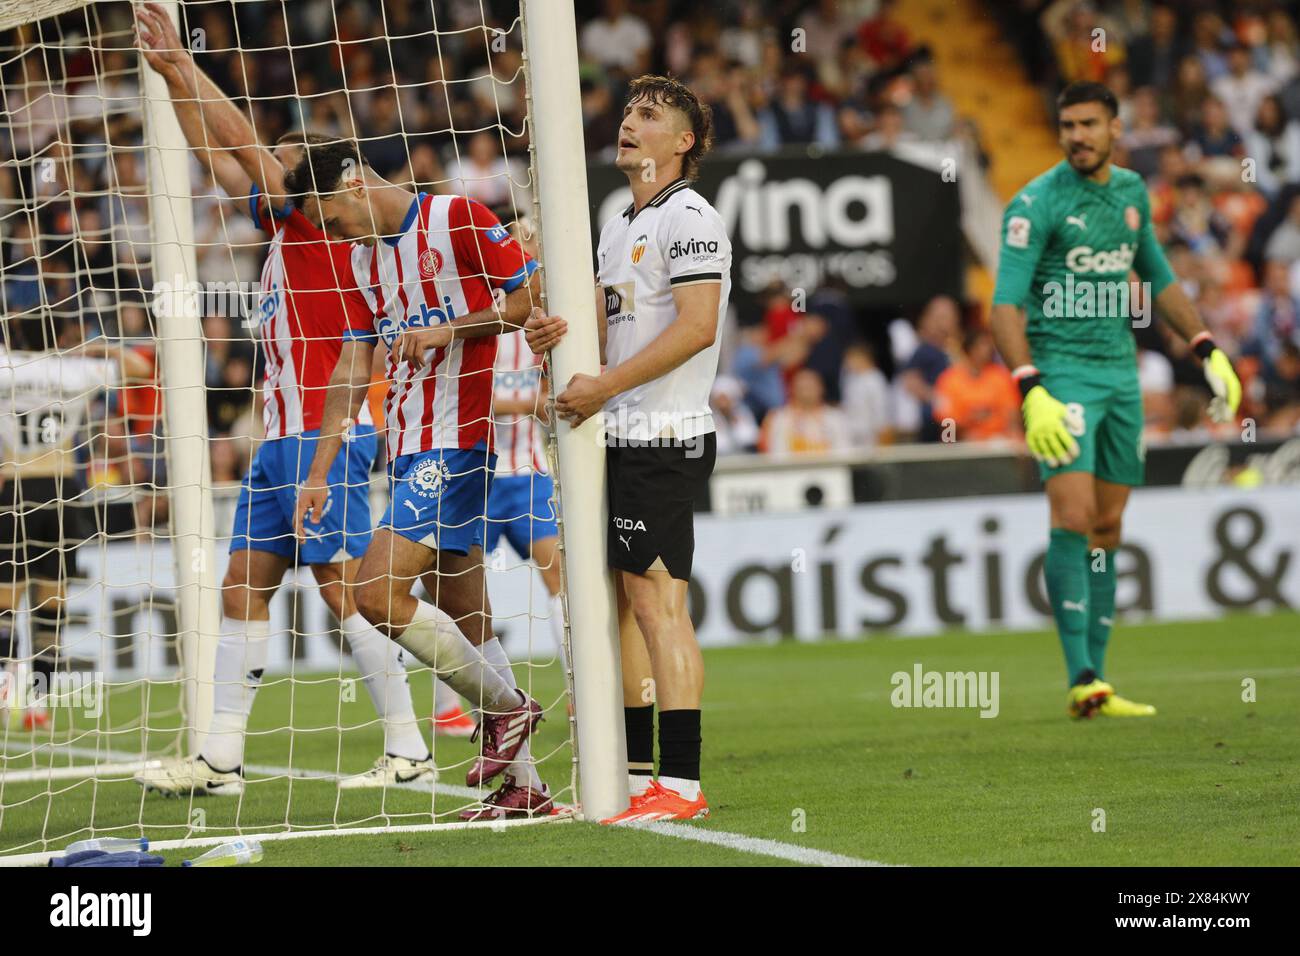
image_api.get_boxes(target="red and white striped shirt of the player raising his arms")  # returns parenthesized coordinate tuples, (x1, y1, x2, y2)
(248, 186, 371, 438)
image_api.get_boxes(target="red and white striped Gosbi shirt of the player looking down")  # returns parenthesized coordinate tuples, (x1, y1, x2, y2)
(345, 193, 537, 462)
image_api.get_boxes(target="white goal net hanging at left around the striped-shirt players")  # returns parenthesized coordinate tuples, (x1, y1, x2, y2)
(0, 0, 598, 862)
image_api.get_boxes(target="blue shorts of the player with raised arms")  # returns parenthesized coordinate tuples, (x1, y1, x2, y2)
(230, 425, 378, 564)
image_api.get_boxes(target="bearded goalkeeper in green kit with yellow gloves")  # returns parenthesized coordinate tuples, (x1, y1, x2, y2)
(992, 83, 1242, 718)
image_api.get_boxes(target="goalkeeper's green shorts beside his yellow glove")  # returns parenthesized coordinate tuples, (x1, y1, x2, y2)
(1035, 359, 1147, 485)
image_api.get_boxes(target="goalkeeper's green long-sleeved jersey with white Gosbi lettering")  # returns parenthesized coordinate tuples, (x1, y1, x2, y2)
(993, 160, 1174, 364)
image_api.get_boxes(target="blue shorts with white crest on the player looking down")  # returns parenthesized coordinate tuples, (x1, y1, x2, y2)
(380, 445, 497, 554)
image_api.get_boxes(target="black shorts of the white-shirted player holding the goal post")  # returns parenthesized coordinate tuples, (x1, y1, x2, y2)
(606, 433, 718, 581)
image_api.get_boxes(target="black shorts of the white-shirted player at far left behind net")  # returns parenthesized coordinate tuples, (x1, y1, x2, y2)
(0, 475, 96, 587)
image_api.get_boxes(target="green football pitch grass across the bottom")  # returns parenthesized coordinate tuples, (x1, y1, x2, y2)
(0, 613, 1300, 866)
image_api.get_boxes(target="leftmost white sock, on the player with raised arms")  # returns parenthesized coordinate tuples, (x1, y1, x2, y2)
(200, 617, 270, 770)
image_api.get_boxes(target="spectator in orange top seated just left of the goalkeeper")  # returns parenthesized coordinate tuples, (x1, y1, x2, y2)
(933, 329, 1021, 441)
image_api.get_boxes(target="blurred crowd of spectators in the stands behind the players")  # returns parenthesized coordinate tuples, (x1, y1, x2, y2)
(0, 0, 1300, 509)
